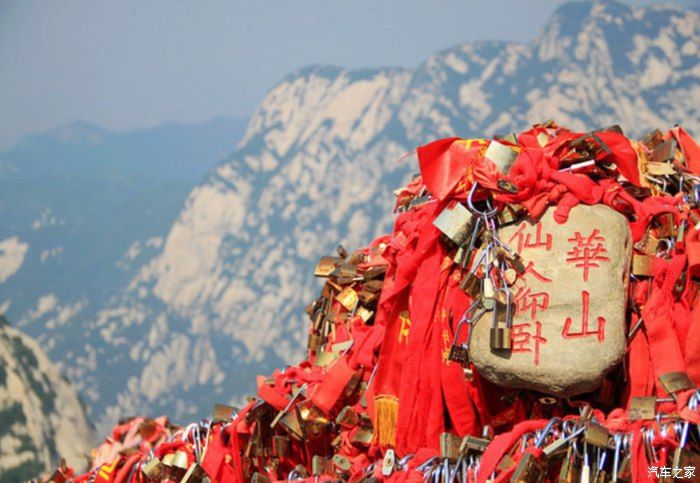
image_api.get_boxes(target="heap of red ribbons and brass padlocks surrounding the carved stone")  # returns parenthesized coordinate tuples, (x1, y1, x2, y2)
(51, 122, 700, 483)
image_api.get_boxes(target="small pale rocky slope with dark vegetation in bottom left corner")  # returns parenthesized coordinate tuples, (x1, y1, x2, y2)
(0, 317, 94, 482)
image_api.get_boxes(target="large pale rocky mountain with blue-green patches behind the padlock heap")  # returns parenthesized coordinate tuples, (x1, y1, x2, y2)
(5, 1, 700, 427)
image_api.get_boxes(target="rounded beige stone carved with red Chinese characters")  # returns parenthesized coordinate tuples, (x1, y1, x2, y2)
(469, 205, 632, 397)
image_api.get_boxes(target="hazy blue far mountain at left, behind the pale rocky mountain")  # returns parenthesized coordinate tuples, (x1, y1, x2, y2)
(0, 118, 245, 424)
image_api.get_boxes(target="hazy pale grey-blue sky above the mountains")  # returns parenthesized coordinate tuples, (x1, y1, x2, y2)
(0, 0, 700, 148)
